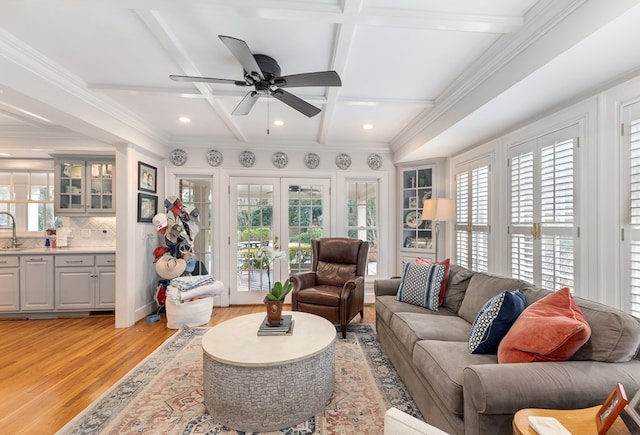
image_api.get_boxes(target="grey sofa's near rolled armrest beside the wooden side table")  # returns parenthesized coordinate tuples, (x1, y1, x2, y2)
(463, 360, 640, 420)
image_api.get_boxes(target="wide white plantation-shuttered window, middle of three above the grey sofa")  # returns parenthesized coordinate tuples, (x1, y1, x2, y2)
(509, 125, 578, 290)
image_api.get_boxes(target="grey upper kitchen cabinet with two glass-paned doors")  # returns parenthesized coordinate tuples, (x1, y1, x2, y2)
(55, 156, 116, 216)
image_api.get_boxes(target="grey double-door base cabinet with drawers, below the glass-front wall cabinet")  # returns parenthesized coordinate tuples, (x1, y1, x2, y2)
(55, 254, 115, 310)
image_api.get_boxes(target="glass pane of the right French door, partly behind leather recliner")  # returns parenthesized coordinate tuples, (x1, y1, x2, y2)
(282, 184, 324, 273)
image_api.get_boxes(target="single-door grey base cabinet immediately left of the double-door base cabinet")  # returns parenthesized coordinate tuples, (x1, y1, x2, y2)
(20, 255, 54, 311)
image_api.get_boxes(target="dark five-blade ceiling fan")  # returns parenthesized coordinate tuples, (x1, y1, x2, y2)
(169, 35, 342, 117)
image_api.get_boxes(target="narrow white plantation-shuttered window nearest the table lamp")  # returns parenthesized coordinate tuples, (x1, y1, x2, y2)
(456, 157, 491, 272)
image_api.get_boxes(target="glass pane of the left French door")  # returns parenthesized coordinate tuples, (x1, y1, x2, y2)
(236, 184, 274, 291)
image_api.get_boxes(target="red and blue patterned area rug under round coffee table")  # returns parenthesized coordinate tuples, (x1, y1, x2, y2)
(58, 324, 422, 435)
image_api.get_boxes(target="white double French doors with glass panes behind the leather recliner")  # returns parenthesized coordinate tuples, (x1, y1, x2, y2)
(229, 177, 330, 305)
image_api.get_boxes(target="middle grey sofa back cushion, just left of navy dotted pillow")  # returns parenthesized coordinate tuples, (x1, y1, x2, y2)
(458, 272, 531, 323)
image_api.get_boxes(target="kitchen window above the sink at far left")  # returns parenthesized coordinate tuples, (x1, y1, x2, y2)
(0, 171, 61, 232)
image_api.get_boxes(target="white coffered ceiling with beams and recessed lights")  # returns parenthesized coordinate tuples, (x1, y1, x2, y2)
(0, 0, 640, 161)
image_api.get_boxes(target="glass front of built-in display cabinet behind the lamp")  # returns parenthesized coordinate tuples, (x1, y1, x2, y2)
(400, 167, 435, 262)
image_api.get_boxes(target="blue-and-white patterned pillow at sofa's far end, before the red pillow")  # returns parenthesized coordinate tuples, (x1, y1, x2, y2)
(396, 263, 447, 311)
